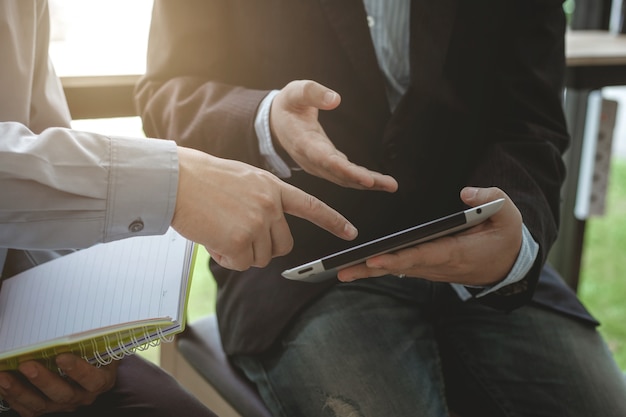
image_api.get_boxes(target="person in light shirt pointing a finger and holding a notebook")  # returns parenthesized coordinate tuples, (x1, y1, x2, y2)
(0, 0, 364, 417)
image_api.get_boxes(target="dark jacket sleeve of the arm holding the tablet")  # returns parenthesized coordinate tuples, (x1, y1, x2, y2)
(460, 1, 569, 309)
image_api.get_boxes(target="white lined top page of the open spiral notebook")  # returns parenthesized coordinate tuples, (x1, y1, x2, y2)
(0, 228, 190, 353)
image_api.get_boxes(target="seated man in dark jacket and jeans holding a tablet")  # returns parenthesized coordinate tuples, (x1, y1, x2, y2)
(136, 0, 626, 416)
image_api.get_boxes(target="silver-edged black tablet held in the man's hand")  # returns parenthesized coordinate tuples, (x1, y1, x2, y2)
(282, 198, 504, 282)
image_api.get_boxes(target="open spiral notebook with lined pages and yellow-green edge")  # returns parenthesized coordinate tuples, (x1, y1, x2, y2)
(0, 228, 196, 370)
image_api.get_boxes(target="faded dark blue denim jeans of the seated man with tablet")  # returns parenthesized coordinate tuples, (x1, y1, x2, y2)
(234, 277, 626, 417)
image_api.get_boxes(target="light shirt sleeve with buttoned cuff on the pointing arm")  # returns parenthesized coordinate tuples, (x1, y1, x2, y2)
(0, 122, 178, 249)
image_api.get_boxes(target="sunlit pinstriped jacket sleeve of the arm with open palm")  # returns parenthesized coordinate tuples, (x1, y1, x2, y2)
(135, 1, 269, 166)
